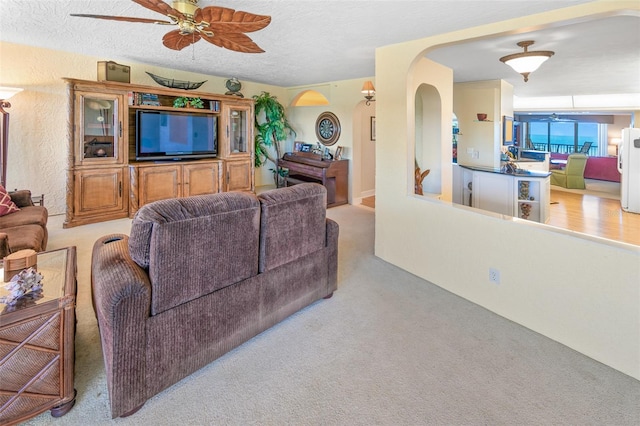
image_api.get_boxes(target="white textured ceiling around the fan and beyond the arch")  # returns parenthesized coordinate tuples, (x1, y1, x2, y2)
(0, 0, 640, 96)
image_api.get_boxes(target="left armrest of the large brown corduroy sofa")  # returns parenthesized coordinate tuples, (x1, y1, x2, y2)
(91, 234, 151, 418)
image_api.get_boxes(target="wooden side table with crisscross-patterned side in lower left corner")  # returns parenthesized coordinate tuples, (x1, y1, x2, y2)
(0, 247, 76, 425)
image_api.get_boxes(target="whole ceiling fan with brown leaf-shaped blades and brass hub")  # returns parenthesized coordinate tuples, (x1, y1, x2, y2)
(71, 0, 271, 53)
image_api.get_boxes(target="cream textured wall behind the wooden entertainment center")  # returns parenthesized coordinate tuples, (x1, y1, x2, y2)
(0, 42, 286, 215)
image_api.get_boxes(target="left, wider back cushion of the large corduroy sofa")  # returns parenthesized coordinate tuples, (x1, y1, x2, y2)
(129, 192, 260, 315)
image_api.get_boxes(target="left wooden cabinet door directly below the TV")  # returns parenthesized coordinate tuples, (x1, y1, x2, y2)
(138, 165, 182, 207)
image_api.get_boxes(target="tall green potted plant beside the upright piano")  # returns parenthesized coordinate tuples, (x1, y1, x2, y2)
(253, 92, 296, 188)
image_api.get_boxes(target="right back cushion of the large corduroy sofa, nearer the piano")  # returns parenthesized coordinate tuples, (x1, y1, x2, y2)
(258, 183, 327, 272)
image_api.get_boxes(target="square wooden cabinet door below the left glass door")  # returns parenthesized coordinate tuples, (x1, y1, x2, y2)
(74, 167, 126, 217)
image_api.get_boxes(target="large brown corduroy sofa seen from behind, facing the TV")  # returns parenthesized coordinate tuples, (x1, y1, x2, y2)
(91, 183, 338, 418)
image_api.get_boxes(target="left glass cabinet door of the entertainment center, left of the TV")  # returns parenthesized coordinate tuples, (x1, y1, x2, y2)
(76, 94, 122, 162)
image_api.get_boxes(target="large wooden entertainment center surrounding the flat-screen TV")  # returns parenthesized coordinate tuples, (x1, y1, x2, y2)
(64, 79, 255, 228)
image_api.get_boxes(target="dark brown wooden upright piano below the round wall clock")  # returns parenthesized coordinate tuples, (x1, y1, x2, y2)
(278, 152, 349, 207)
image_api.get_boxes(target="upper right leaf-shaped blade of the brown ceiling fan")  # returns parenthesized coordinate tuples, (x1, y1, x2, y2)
(194, 6, 271, 33)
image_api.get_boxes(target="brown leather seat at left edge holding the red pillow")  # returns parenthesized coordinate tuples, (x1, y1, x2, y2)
(0, 189, 49, 259)
